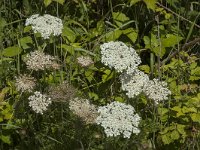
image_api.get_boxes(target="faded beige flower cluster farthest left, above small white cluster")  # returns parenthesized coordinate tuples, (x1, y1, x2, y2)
(15, 74, 35, 92)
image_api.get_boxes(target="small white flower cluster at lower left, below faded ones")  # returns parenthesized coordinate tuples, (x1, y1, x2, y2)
(28, 91, 52, 114)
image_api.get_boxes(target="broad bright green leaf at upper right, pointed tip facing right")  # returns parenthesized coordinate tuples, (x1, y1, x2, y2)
(161, 34, 183, 47)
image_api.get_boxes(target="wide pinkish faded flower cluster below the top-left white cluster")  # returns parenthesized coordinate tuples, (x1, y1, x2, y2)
(24, 50, 59, 71)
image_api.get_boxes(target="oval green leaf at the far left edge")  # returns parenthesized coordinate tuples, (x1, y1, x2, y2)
(2, 46, 22, 57)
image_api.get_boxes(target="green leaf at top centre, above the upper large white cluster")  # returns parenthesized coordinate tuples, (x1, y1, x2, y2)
(112, 12, 130, 27)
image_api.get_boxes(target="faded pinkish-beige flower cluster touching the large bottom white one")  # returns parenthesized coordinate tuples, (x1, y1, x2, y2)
(69, 98, 98, 124)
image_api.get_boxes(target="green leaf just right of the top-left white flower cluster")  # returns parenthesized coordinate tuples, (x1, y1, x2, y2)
(62, 26, 76, 43)
